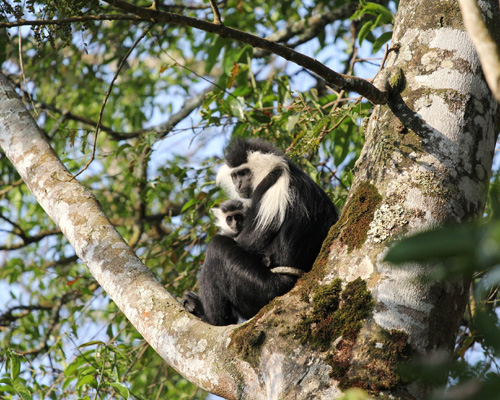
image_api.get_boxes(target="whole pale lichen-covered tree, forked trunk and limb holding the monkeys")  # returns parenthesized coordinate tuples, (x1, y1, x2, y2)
(0, 0, 499, 399)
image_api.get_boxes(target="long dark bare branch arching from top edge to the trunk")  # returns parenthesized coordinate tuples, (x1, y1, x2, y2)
(101, 0, 389, 104)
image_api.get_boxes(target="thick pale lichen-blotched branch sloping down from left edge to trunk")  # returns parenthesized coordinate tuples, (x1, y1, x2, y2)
(0, 74, 248, 398)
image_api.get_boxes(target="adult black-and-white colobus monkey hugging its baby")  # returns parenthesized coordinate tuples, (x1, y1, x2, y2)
(183, 139, 338, 325)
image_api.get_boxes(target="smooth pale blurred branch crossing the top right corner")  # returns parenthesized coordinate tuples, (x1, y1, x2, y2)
(458, 0, 500, 102)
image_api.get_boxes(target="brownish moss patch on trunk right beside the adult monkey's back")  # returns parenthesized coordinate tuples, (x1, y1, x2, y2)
(330, 182, 382, 251)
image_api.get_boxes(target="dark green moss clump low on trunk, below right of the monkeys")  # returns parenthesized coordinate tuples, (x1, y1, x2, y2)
(287, 278, 373, 351)
